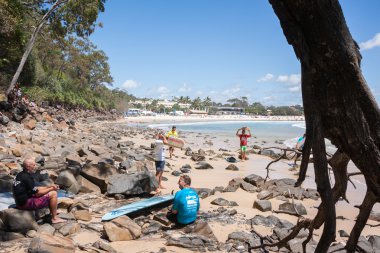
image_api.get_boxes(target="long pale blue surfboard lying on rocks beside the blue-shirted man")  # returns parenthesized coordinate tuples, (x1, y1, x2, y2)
(102, 194, 174, 221)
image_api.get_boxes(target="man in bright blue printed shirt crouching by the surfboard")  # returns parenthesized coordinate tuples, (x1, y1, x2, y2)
(168, 175, 199, 226)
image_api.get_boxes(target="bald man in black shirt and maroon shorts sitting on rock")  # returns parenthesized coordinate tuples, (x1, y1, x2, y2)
(13, 158, 65, 223)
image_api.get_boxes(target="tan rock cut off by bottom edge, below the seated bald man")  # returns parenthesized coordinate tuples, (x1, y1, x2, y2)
(28, 233, 75, 253)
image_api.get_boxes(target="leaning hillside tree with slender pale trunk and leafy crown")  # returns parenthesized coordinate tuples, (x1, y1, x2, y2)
(6, 0, 105, 94)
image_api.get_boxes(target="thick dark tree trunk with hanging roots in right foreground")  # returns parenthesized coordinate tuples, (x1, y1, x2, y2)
(269, 0, 380, 252)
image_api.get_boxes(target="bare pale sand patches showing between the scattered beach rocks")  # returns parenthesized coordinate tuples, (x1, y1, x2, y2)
(102, 117, 380, 252)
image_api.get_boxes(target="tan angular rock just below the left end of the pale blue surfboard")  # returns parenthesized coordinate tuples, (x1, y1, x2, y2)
(104, 216, 141, 242)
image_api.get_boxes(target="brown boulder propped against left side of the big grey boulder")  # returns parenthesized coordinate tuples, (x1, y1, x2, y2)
(81, 163, 118, 193)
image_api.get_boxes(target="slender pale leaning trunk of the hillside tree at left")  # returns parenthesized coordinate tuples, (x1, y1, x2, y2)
(6, 0, 67, 95)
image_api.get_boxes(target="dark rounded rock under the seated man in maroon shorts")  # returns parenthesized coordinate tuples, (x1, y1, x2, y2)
(1, 208, 38, 234)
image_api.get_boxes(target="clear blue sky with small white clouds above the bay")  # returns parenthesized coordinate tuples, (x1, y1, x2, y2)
(91, 0, 380, 106)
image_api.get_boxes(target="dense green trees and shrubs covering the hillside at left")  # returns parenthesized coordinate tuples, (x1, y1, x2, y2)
(0, 0, 133, 109)
